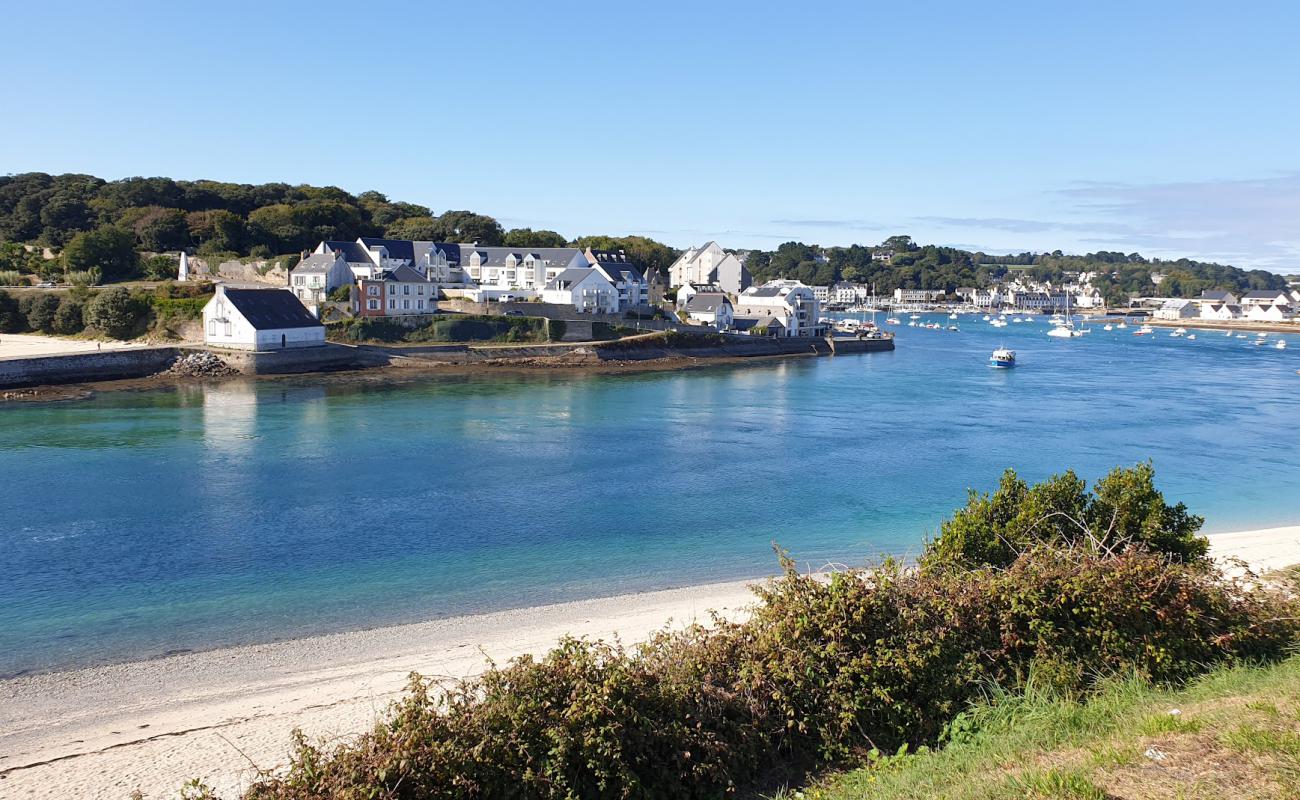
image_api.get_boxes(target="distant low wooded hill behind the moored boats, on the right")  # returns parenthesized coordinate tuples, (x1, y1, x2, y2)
(746, 235, 1286, 304)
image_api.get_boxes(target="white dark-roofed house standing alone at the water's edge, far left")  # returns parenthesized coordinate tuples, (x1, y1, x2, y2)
(203, 285, 325, 350)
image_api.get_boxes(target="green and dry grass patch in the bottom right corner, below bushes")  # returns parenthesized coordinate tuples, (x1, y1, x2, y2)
(777, 656, 1300, 800)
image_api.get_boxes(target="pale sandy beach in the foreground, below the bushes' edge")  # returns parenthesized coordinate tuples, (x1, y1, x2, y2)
(0, 526, 1300, 799)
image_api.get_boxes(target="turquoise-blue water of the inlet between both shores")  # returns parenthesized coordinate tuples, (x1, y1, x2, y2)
(0, 317, 1300, 674)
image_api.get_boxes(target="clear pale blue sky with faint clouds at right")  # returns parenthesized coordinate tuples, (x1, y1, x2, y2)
(0, 0, 1300, 272)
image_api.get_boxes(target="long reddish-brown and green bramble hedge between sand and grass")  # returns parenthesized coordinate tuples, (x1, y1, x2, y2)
(246, 470, 1300, 800)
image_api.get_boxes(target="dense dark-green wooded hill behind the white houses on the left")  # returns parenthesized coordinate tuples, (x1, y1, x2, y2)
(0, 172, 677, 280)
